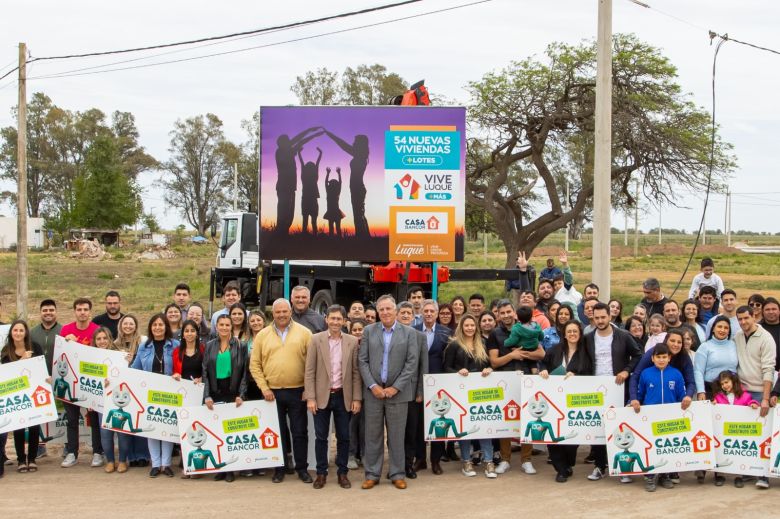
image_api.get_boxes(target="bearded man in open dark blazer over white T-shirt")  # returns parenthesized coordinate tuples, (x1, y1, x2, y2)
(585, 303, 642, 481)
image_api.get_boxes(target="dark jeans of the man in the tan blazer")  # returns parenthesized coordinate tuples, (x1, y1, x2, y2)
(314, 391, 352, 476)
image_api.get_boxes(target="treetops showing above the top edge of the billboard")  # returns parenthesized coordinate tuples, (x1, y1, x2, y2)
(290, 63, 408, 105)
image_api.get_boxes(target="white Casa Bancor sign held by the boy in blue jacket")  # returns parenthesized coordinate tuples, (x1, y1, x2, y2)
(604, 401, 715, 476)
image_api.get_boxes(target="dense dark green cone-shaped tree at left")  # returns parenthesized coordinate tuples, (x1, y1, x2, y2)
(71, 135, 142, 229)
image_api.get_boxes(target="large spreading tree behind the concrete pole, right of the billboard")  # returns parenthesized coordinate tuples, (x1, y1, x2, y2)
(466, 35, 734, 267)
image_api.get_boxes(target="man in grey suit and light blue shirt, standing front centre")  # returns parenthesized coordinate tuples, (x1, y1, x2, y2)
(358, 295, 420, 490)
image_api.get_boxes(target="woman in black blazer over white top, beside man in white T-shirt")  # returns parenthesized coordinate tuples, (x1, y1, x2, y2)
(539, 321, 593, 483)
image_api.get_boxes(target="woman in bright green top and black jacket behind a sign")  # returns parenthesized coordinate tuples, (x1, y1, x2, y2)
(203, 315, 248, 483)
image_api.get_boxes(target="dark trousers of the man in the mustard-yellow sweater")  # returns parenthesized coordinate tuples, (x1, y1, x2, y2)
(272, 387, 309, 472)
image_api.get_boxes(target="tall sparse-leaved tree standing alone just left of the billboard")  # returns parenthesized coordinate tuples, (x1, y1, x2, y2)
(163, 114, 234, 235)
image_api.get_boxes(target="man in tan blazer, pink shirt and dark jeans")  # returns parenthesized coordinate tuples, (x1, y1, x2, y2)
(303, 305, 363, 489)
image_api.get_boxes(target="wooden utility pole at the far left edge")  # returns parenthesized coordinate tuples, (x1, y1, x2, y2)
(16, 43, 27, 320)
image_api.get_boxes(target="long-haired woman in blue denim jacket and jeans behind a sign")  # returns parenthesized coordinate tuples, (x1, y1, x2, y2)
(130, 313, 179, 478)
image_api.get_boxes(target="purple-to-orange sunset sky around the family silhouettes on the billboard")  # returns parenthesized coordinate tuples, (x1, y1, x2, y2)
(260, 107, 465, 236)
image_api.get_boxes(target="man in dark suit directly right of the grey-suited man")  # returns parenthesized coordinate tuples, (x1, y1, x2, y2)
(406, 299, 450, 477)
